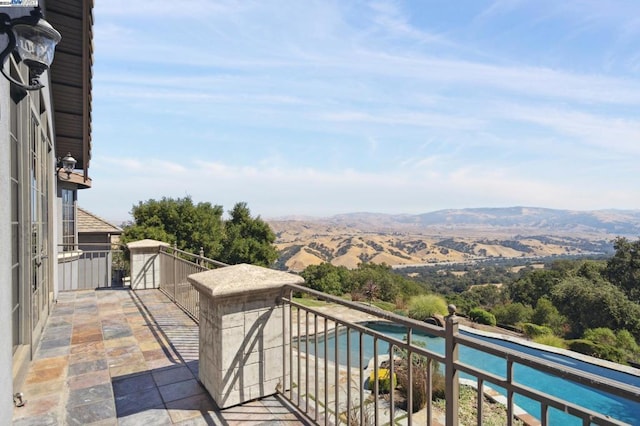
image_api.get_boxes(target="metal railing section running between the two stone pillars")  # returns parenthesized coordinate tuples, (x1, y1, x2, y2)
(159, 246, 228, 322)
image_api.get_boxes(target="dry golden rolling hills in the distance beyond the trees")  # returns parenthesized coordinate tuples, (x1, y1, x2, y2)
(269, 220, 604, 271)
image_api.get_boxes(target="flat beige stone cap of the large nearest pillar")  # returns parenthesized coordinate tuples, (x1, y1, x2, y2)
(188, 263, 304, 297)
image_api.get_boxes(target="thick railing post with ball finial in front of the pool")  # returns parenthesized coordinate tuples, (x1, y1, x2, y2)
(445, 305, 460, 426)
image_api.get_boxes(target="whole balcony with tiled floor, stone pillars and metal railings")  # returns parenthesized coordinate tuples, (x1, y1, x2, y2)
(14, 241, 640, 425)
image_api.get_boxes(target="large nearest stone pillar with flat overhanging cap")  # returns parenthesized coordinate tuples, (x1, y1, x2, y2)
(188, 264, 304, 408)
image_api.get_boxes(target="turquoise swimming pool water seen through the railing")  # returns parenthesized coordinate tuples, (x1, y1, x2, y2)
(300, 323, 640, 425)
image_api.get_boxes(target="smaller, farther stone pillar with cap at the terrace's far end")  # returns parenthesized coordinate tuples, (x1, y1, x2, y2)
(127, 240, 169, 290)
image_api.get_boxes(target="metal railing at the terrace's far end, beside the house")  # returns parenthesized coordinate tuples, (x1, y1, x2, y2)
(57, 243, 128, 291)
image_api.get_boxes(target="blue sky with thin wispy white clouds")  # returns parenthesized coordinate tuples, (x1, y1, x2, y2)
(79, 0, 640, 223)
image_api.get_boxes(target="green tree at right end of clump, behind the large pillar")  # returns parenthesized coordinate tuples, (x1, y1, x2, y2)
(220, 202, 278, 267)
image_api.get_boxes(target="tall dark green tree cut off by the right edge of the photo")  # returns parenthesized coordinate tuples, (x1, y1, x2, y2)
(604, 237, 640, 303)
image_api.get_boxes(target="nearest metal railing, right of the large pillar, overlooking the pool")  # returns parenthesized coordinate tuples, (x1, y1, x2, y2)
(279, 285, 640, 426)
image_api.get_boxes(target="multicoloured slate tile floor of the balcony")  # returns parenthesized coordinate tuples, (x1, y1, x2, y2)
(13, 289, 308, 426)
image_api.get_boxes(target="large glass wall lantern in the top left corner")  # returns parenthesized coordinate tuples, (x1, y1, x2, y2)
(0, 8, 62, 90)
